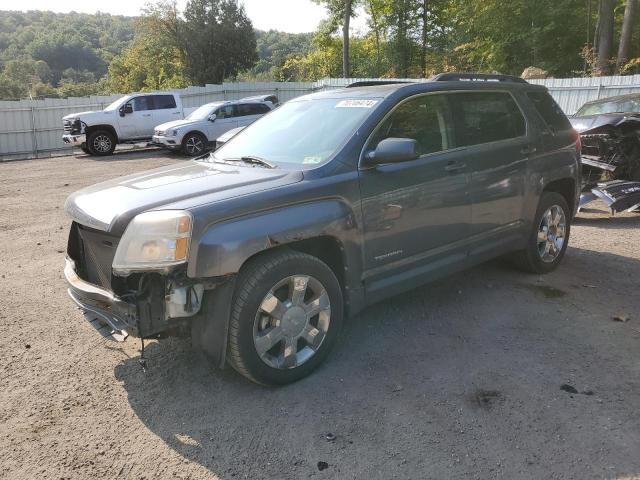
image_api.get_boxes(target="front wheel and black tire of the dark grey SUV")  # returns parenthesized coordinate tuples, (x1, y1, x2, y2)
(227, 249, 343, 385)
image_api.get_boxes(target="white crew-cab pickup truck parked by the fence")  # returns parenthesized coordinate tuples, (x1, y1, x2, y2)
(62, 93, 195, 156)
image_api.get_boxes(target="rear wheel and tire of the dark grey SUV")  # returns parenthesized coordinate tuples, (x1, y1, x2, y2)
(514, 192, 571, 274)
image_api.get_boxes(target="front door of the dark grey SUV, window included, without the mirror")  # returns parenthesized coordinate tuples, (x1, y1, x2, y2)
(360, 94, 471, 294)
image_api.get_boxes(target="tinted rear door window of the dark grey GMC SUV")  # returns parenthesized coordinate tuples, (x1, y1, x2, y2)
(450, 92, 526, 147)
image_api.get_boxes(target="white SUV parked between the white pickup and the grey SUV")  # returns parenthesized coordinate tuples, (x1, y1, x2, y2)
(153, 99, 275, 157)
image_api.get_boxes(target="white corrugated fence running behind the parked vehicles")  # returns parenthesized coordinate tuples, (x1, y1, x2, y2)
(0, 75, 640, 160)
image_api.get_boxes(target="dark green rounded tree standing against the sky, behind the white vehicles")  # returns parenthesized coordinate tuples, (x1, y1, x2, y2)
(180, 0, 257, 85)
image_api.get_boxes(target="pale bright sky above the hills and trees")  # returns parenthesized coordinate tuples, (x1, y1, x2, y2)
(6, 0, 358, 33)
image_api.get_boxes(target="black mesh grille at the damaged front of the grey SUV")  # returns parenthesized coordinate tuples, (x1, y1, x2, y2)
(69, 223, 120, 290)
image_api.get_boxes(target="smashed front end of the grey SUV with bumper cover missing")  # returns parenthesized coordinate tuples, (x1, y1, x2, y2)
(64, 222, 204, 338)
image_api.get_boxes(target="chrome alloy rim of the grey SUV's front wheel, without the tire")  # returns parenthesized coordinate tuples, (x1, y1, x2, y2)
(253, 275, 331, 370)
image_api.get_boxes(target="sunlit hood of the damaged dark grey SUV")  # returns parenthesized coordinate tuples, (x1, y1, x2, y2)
(65, 161, 303, 235)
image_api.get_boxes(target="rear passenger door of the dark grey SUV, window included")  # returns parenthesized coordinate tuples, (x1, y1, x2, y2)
(449, 90, 536, 256)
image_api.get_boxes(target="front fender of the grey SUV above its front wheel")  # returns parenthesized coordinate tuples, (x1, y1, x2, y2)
(187, 199, 361, 283)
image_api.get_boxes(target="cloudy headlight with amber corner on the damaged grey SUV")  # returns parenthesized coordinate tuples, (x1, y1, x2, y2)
(113, 210, 193, 271)
